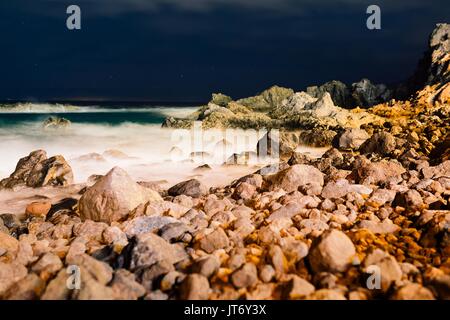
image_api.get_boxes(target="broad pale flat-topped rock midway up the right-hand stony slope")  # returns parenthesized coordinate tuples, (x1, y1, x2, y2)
(267, 164, 323, 192)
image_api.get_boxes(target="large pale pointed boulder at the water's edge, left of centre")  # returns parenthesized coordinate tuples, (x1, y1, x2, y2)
(78, 167, 162, 223)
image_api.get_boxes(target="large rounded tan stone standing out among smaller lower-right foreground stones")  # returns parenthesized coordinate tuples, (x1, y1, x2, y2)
(308, 230, 356, 272)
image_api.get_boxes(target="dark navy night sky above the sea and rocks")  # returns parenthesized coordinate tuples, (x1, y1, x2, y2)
(0, 0, 450, 102)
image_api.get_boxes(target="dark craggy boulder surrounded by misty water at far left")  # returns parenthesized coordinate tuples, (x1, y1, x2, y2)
(0, 150, 73, 188)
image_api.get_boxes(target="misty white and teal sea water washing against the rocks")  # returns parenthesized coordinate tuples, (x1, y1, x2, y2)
(0, 104, 270, 186)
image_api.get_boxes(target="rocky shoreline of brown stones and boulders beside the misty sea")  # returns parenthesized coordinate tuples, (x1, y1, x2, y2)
(0, 24, 450, 300)
